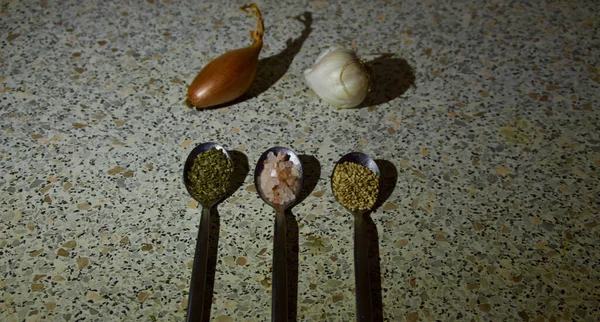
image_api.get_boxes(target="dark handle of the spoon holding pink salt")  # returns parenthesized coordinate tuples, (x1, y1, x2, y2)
(271, 210, 288, 322)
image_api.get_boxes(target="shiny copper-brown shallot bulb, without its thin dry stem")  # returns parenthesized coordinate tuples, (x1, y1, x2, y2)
(187, 42, 262, 108)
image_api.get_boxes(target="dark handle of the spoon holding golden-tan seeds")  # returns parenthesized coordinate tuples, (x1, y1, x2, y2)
(354, 214, 373, 322)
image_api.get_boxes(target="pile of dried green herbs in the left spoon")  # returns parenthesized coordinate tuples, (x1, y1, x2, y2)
(188, 147, 233, 203)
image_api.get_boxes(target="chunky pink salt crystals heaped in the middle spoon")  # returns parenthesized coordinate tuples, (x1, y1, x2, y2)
(260, 152, 300, 205)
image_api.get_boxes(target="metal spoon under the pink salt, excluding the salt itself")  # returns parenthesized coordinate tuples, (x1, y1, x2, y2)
(254, 147, 304, 322)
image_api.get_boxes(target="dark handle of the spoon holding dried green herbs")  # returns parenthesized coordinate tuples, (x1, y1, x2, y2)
(186, 207, 210, 322)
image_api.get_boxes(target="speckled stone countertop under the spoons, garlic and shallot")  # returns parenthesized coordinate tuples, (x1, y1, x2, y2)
(0, 0, 600, 322)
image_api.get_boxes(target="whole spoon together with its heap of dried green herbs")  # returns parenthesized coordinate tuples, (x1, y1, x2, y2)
(183, 142, 233, 321)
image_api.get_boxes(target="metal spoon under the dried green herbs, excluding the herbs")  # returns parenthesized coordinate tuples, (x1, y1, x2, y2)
(183, 142, 233, 321)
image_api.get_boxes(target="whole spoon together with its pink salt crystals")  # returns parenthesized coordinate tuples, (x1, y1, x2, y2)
(254, 147, 304, 322)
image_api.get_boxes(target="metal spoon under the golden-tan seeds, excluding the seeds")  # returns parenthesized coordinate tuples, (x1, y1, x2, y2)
(331, 152, 381, 322)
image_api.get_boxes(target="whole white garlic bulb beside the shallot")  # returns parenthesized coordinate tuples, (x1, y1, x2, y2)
(304, 47, 369, 108)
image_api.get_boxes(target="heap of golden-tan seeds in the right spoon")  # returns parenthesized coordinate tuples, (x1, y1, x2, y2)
(332, 162, 379, 211)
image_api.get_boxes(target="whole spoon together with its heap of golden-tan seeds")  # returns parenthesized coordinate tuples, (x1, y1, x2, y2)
(331, 152, 381, 322)
